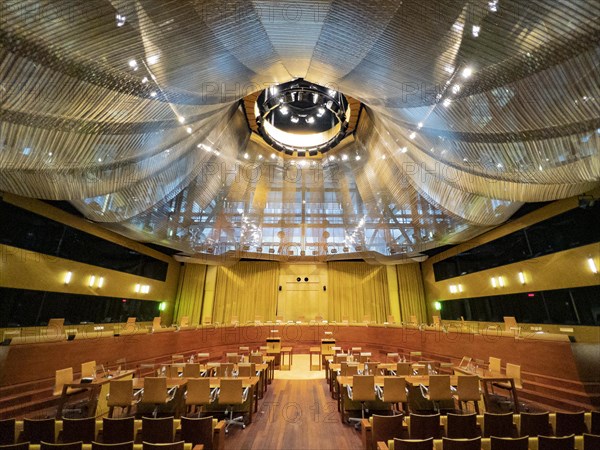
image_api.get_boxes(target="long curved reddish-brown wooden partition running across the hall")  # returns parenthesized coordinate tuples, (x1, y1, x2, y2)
(0, 324, 600, 414)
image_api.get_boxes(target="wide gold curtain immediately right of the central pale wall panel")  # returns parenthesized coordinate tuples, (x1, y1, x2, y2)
(327, 262, 390, 323)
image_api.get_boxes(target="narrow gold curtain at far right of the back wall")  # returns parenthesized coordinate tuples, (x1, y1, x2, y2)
(396, 263, 427, 323)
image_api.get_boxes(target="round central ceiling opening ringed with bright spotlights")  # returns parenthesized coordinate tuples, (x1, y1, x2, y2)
(254, 78, 351, 156)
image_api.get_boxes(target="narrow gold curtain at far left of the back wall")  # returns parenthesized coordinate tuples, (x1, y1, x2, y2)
(175, 264, 206, 325)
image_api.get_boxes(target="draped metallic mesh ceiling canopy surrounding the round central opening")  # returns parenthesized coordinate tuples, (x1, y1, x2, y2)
(0, 0, 600, 263)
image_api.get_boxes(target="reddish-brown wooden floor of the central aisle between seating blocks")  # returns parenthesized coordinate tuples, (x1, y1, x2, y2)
(225, 379, 362, 450)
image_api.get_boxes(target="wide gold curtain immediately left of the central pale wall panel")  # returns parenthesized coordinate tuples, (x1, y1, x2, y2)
(213, 261, 279, 324)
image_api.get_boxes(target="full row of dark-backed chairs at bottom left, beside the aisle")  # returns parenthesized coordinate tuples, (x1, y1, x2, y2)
(0, 416, 226, 449)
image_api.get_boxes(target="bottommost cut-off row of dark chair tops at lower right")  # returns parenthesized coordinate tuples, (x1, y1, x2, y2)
(377, 434, 600, 450)
